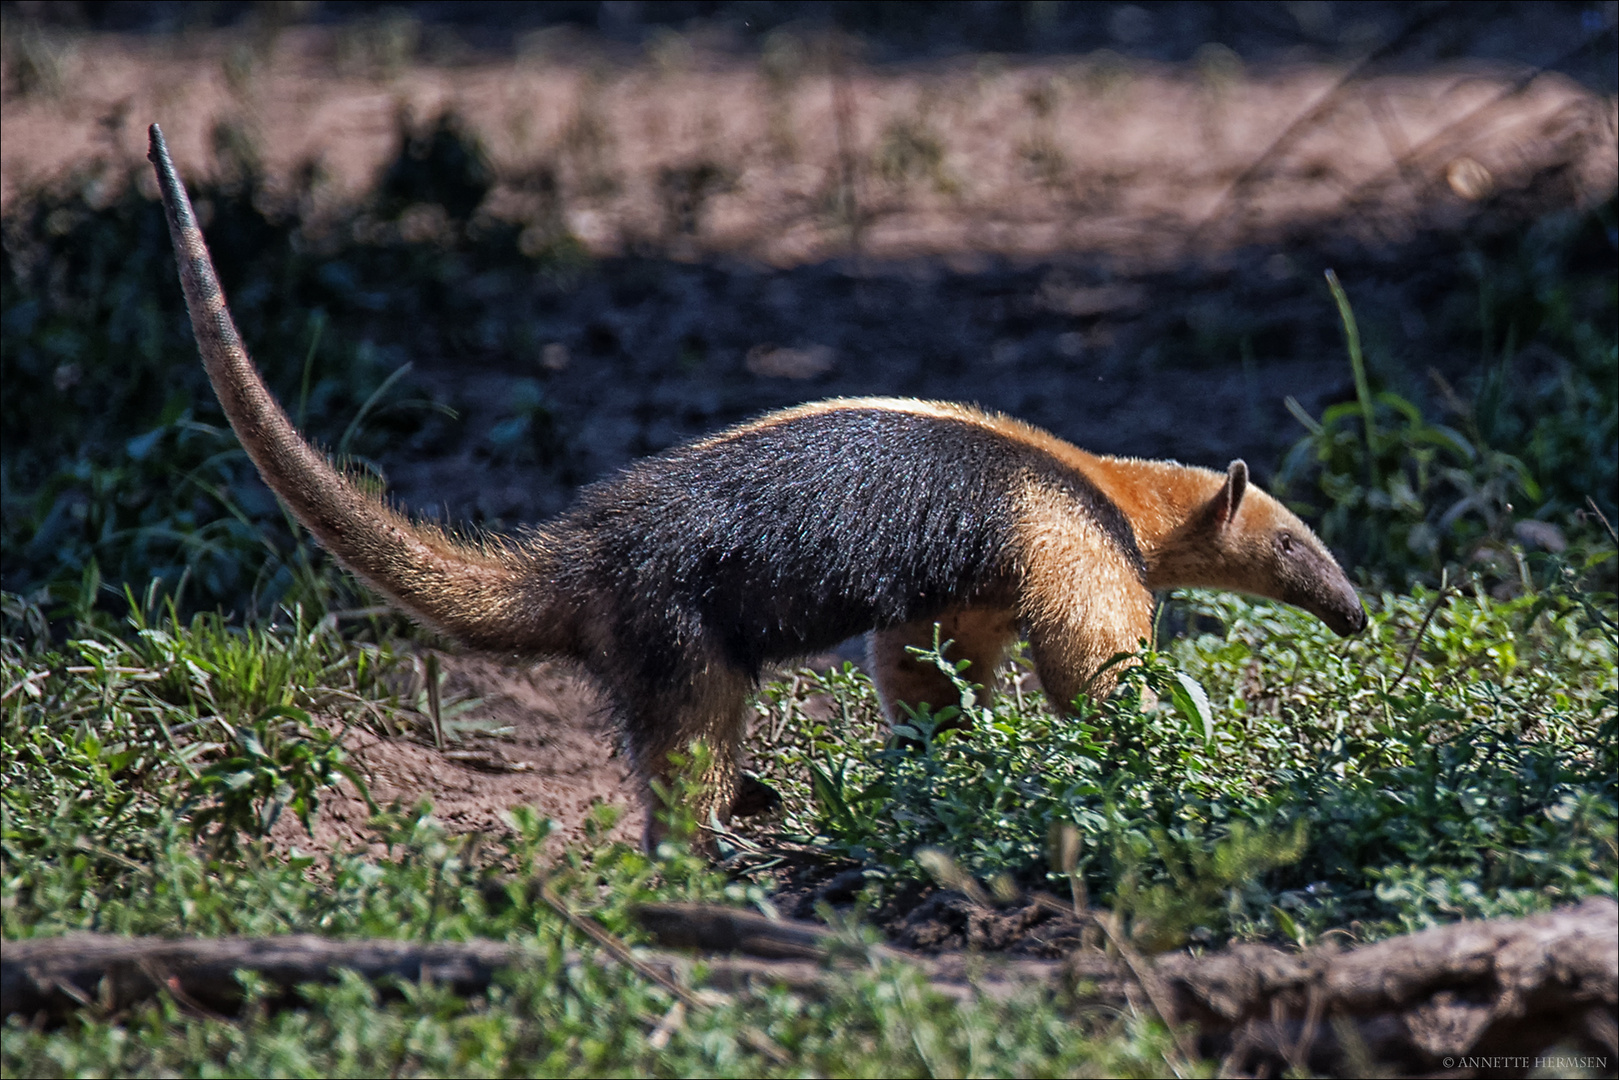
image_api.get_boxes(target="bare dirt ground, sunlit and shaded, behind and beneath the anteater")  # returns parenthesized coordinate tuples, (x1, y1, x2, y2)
(0, 5, 1619, 906)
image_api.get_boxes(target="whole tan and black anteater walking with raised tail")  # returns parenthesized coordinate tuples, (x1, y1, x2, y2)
(149, 125, 1366, 842)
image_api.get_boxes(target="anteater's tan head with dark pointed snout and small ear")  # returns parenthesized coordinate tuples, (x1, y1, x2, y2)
(1154, 460, 1366, 636)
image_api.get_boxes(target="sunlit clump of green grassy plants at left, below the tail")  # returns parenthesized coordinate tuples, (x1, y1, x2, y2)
(0, 581, 417, 853)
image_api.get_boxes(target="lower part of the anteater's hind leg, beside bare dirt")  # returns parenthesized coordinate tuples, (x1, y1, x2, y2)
(614, 659, 754, 852)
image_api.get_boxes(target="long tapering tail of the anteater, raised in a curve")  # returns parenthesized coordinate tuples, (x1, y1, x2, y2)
(147, 123, 567, 653)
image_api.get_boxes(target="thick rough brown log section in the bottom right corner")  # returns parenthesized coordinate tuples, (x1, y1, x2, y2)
(1153, 897, 1619, 1075)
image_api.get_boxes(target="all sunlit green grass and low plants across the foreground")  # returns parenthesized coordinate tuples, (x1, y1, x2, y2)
(0, 537, 1619, 1075)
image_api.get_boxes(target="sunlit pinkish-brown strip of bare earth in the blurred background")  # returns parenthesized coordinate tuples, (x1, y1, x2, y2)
(0, 26, 1616, 269)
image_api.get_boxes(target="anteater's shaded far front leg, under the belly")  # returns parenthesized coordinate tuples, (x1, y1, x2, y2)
(866, 607, 1017, 727)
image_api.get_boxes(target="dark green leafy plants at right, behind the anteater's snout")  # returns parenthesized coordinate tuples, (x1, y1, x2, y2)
(1279, 201, 1619, 595)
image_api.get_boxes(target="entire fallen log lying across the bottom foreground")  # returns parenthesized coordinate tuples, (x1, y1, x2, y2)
(0, 899, 1619, 1075)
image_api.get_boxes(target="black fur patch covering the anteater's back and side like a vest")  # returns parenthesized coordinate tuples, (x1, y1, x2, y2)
(542, 406, 1145, 695)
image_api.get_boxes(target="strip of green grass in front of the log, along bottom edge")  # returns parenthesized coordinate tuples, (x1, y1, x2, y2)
(3, 926, 1185, 1077)
